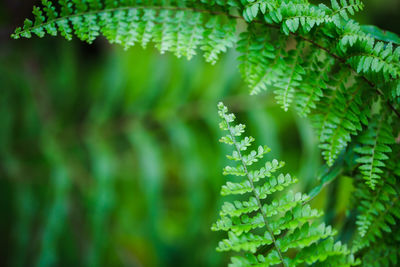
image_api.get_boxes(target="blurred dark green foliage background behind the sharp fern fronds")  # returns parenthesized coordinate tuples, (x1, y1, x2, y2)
(0, 0, 400, 267)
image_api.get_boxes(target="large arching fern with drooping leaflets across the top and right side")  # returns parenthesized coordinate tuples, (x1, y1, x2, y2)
(12, 0, 400, 264)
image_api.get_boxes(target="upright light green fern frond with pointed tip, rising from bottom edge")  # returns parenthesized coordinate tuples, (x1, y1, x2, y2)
(212, 103, 358, 266)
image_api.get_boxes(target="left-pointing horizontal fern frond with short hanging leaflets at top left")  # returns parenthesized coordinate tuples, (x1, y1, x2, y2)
(12, 0, 236, 63)
